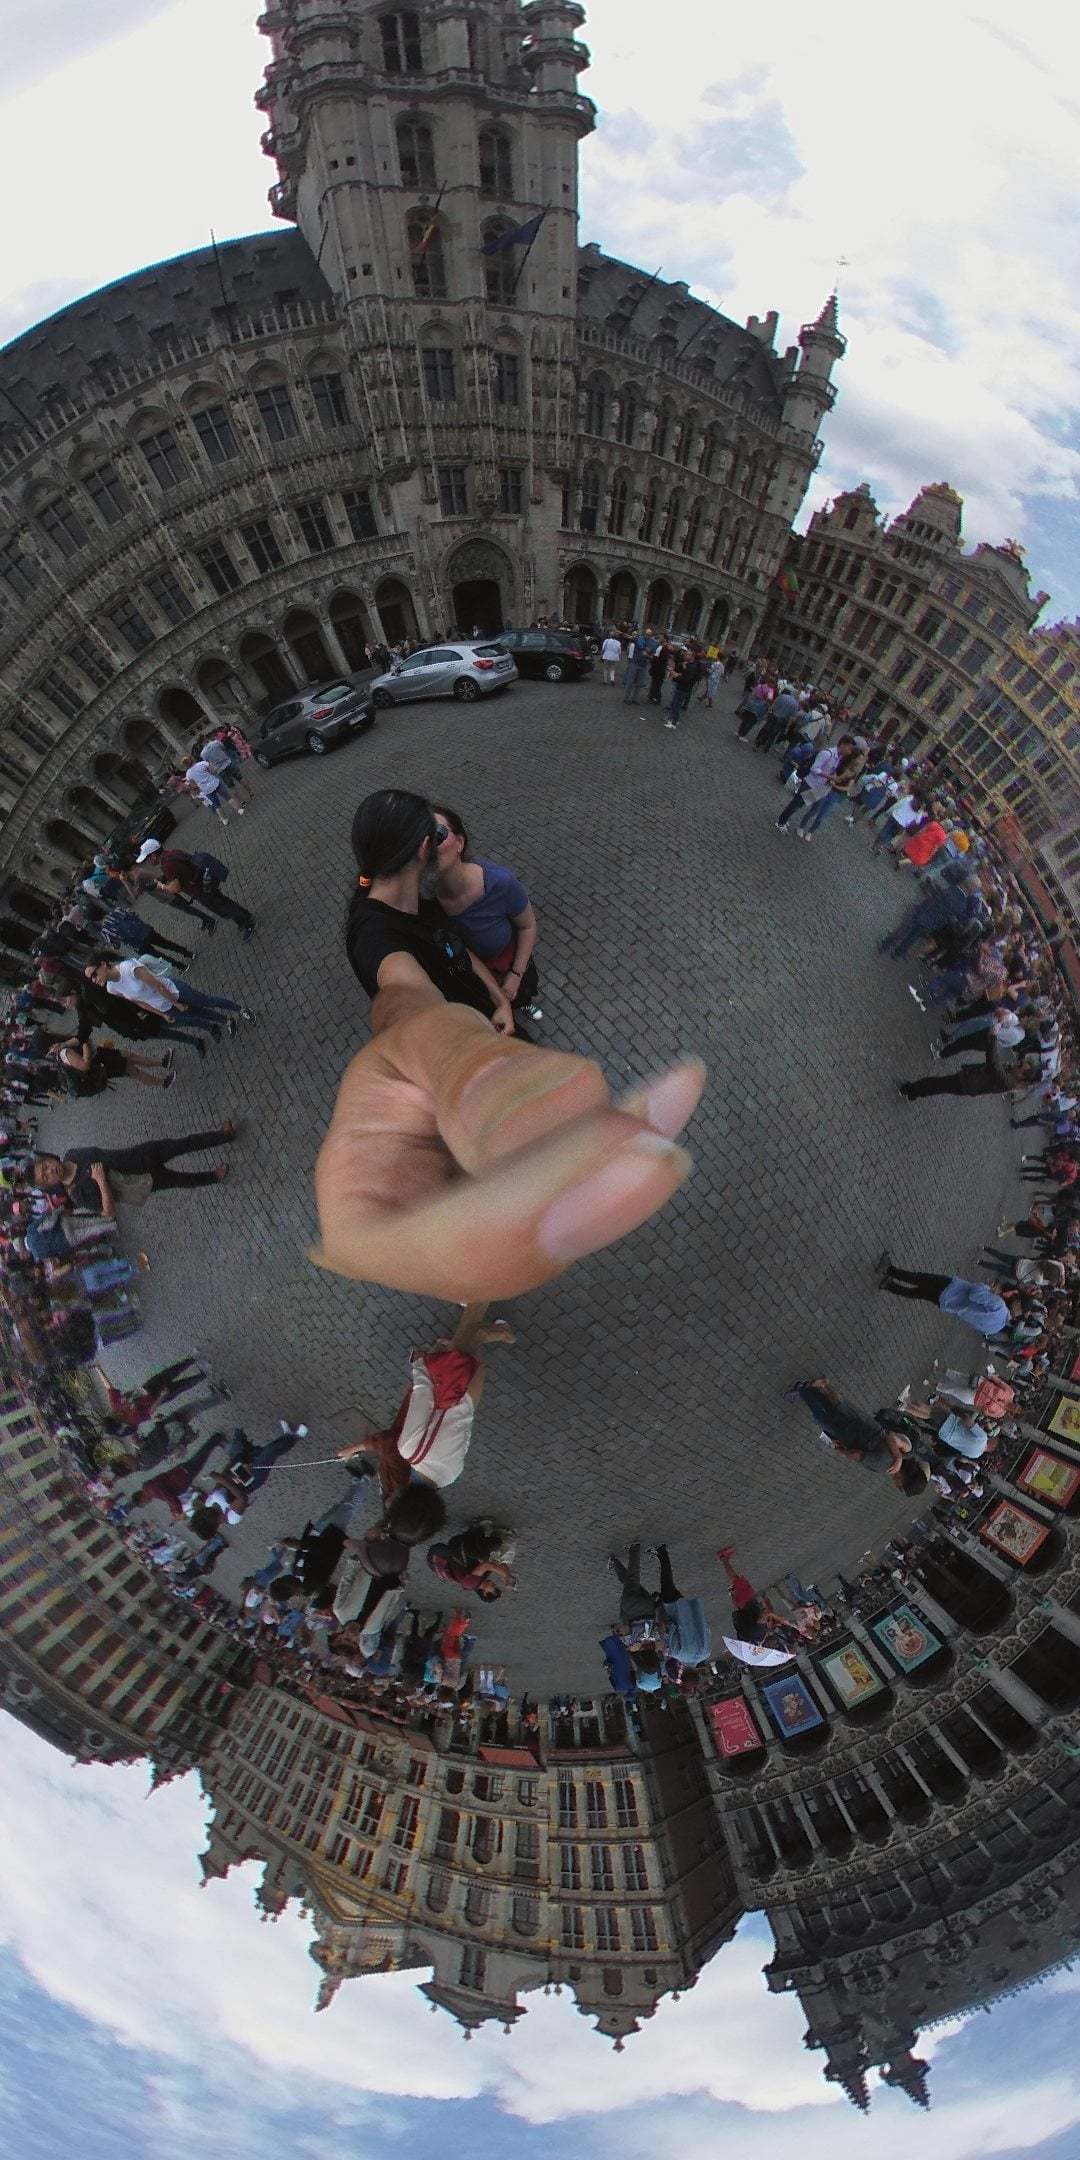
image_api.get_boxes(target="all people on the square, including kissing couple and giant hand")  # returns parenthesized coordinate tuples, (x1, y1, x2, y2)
(0, 629, 1080, 1737)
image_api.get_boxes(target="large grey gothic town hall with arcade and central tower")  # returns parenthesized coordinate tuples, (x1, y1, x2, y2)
(0, 0, 845, 972)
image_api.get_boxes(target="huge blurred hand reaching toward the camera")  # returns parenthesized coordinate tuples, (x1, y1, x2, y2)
(311, 994, 704, 1302)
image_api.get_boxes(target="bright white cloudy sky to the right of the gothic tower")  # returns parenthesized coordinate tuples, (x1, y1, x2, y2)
(583, 0, 1080, 605)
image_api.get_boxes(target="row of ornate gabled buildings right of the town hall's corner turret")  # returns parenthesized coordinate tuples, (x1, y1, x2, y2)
(762, 482, 1080, 872)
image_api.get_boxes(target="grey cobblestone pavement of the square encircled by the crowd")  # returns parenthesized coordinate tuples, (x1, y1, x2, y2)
(43, 680, 1017, 1693)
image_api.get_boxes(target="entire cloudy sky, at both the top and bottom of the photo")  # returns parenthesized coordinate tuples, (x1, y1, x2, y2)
(0, 0, 1080, 2160)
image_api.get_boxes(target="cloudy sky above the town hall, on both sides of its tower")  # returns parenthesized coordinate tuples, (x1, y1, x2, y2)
(0, 0, 1080, 622)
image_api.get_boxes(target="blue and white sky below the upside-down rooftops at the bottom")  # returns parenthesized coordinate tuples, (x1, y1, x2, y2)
(0, 1719, 1080, 2160)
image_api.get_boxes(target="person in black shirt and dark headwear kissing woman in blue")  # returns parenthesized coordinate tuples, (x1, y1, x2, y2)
(346, 788, 514, 1035)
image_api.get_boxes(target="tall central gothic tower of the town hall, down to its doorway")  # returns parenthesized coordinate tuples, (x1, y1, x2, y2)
(259, 0, 594, 637)
